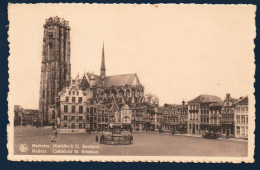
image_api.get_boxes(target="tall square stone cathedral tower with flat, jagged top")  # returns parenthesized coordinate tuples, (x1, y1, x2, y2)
(39, 17, 71, 124)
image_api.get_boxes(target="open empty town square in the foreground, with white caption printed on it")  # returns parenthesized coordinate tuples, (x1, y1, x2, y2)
(14, 126, 248, 157)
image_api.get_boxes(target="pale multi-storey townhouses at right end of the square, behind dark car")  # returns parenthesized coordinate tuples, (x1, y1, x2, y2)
(187, 94, 248, 138)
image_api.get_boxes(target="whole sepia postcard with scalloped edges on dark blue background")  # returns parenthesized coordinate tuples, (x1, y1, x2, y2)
(7, 3, 256, 163)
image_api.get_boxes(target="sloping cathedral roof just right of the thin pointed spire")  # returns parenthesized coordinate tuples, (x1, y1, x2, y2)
(104, 73, 141, 87)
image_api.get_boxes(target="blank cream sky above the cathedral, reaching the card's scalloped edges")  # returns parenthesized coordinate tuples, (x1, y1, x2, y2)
(8, 4, 256, 109)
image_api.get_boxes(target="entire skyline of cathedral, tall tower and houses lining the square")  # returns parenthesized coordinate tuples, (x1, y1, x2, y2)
(31, 17, 248, 137)
